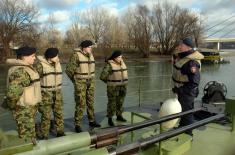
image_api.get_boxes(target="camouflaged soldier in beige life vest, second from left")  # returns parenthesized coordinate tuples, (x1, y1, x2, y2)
(35, 48, 65, 139)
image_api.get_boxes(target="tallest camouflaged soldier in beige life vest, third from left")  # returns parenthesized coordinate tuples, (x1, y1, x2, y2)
(65, 40, 100, 132)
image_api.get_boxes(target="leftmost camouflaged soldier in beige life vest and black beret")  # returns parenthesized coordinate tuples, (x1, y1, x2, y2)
(7, 47, 41, 144)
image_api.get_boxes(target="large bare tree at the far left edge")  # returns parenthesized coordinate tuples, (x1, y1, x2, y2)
(0, 0, 38, 61)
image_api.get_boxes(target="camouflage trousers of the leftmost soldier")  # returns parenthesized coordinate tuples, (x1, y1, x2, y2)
(12, 106, 37, 139)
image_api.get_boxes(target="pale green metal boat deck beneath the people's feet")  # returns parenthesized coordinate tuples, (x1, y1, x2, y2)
(0, 99, 235, 155)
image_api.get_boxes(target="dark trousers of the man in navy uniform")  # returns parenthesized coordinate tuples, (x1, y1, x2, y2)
(178, 93, 195, 135)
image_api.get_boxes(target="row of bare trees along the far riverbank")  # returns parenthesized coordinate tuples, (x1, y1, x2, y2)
(0, 0, 204, 60)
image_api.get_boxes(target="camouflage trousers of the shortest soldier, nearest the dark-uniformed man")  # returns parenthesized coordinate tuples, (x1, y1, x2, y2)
(107, 86, 126, 117)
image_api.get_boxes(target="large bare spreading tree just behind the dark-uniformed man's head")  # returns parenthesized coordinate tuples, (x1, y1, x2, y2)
(152, 2, 201, 54)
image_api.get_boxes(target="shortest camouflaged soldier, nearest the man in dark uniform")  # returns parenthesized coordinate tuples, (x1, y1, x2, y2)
(100, 50, 128, 126)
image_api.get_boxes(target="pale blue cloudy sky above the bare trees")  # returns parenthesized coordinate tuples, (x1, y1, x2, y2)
(27, 0, 235, 38)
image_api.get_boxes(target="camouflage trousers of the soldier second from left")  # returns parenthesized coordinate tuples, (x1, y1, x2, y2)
(38, 90, 64, 137)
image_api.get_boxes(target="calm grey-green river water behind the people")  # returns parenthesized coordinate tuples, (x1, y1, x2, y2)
(0, 56, 235, 118)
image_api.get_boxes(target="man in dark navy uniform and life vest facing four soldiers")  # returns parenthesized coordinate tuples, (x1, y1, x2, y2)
(172, 38, 204, 136)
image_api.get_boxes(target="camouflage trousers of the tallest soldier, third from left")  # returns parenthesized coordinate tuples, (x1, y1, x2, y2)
(74, 79, 95, 126)
